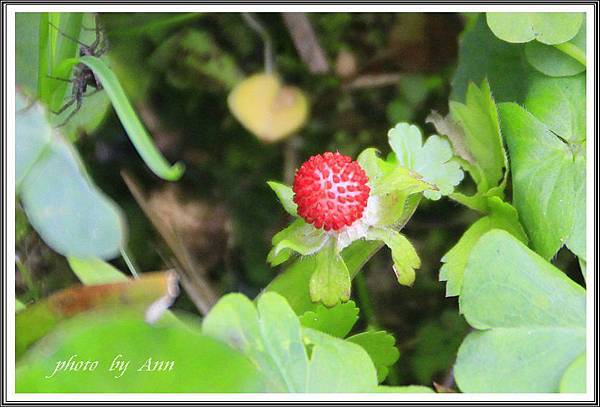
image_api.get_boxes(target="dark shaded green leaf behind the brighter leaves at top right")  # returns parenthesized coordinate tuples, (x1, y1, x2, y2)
(450, 15, 531, 103)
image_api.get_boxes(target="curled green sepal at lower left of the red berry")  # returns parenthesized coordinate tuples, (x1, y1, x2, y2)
(267, 219, 328, 266)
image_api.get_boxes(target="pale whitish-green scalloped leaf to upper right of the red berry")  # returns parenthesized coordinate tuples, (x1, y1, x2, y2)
(388, 123, 464, 200)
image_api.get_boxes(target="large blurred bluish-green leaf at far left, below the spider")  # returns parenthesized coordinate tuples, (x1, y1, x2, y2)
(17, 136, 126, 259)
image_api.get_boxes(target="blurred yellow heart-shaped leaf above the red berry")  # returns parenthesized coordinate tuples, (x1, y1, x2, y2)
(227, 74, 308, 143)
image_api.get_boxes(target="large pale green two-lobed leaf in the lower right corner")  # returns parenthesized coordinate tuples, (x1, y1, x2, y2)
(454, 230, 586, 393)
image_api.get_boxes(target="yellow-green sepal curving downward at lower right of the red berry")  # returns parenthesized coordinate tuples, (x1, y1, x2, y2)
(367, 228, 421, 286)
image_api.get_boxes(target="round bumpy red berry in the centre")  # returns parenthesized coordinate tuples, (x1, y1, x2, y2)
(293, 152, 371, 231)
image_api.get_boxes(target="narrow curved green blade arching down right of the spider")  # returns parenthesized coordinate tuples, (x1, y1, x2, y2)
(79, 56, 184, 181)
